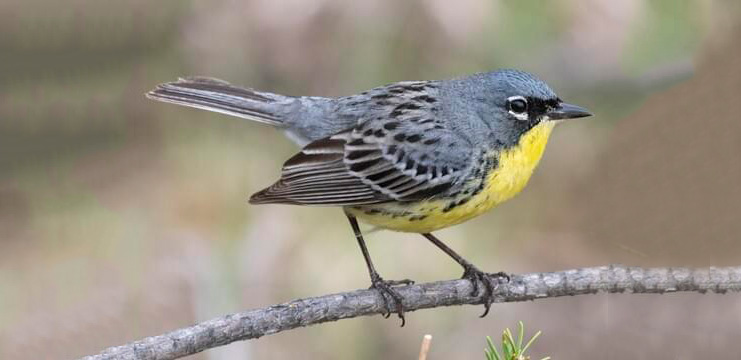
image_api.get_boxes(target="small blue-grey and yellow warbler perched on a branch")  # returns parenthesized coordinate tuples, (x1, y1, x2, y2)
(146, 69, 592, 326)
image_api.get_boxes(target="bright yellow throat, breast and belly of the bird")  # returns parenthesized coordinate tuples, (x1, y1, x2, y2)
(346, 121, 555, 233)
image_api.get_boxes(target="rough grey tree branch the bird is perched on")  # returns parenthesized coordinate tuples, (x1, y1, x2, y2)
(83, 265, 741, 360)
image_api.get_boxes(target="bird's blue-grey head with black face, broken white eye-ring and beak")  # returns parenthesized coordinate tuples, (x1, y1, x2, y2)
(448, 69, 592, 146)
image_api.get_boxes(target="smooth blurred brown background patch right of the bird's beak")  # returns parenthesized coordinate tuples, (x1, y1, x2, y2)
(581, 36, 741, 266)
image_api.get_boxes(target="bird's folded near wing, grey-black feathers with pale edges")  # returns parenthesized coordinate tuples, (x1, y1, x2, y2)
(250, 84, 472, 206)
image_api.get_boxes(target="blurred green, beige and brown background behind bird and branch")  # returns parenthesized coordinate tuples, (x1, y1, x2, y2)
(0, 0, 741, 360)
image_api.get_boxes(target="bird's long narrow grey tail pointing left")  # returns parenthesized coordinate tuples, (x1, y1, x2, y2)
(146, 77, 292, 127)
